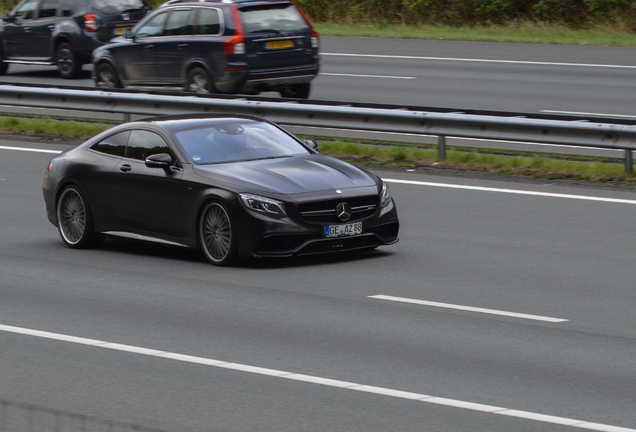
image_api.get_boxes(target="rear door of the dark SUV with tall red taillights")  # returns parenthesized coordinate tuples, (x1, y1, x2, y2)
(155, 9, 193, 84)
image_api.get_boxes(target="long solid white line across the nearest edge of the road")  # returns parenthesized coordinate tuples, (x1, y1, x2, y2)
(0, 324, 636, 432)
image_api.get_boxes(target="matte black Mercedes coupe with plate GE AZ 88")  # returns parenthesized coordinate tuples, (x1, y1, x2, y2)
(42, 115, 399, 265)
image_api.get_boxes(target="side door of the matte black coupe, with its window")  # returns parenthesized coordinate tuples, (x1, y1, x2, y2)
(112, 130, 183, 237)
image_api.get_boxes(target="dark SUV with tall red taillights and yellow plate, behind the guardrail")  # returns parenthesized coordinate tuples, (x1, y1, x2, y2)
(93, 0, 319, 98)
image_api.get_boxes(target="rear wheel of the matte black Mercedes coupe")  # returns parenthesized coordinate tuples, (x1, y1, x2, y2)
(57, 186, 104, 249)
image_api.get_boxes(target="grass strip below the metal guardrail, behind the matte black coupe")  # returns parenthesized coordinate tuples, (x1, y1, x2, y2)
(0, 117, 636, 186)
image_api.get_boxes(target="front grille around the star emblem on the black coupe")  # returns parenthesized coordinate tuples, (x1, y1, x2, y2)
(298, 195, 379, 224)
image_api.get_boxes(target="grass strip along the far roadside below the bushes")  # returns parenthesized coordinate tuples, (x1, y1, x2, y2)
(315, 22, 636, 47)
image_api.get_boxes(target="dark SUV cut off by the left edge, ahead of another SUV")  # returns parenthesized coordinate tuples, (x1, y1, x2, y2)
(0, 0, 151, 78)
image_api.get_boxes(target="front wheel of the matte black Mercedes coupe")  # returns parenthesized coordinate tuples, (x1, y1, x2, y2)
(199, 201, 237, 266)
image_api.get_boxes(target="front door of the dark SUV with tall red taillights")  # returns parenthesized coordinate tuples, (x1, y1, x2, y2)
(117, 11, 169, 85)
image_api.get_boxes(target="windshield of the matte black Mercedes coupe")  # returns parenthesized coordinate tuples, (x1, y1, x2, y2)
(176, 120, 309, 164)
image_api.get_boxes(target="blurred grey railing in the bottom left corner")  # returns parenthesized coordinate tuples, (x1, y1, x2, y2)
(0, 399, 165, 432)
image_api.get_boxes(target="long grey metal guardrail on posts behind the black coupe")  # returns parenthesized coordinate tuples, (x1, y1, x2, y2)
(0, 85, 636, 173)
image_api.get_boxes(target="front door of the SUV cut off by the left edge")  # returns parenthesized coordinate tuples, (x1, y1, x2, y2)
(4, 0, 40, 58)
